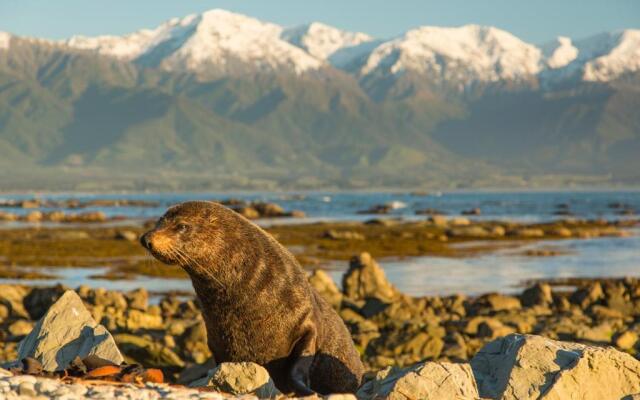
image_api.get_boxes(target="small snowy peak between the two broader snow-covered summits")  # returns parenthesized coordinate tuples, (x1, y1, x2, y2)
(282, 22, 373, 60)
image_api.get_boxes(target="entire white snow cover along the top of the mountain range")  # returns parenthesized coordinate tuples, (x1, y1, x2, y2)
(0, 9, 640, 85)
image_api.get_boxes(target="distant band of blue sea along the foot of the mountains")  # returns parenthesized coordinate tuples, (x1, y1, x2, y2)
(0, 191, 640, 221)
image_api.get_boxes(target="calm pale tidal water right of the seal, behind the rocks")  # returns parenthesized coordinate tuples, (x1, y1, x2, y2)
(330, 236, 640, 296)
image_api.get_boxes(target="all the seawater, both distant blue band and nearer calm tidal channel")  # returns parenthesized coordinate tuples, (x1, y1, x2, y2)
(0, 191, 640, 295)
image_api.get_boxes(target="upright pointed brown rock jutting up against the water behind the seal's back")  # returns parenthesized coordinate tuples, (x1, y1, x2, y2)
(342, 253, 400, 300)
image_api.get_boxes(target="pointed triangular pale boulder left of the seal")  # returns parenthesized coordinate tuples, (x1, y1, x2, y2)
(18, 290, 123, 371)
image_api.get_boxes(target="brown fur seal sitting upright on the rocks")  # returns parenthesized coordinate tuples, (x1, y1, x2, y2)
(140, 201, 364, 396)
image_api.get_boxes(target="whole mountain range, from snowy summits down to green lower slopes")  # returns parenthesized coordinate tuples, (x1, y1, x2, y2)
(0, 10, 640, 190)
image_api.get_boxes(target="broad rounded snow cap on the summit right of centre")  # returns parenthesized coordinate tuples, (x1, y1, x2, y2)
(360, 25, 541, 84)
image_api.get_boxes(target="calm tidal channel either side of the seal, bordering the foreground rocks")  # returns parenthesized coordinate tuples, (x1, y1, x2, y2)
(0, 236, 640, 296)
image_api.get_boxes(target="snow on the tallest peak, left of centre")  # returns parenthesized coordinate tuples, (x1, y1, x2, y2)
(66, 9, 324, 73)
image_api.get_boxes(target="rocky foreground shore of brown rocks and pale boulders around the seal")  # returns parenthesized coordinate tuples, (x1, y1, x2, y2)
(0, 253, 640, 399)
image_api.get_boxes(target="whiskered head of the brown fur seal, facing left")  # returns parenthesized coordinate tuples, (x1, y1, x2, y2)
(140, 201, 224, 268)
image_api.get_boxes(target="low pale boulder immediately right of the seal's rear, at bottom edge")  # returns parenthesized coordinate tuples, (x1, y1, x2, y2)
(357, 362, 480, 400)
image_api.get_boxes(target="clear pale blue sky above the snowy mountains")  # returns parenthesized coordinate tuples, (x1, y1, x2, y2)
(0, 0, 640, 43)
